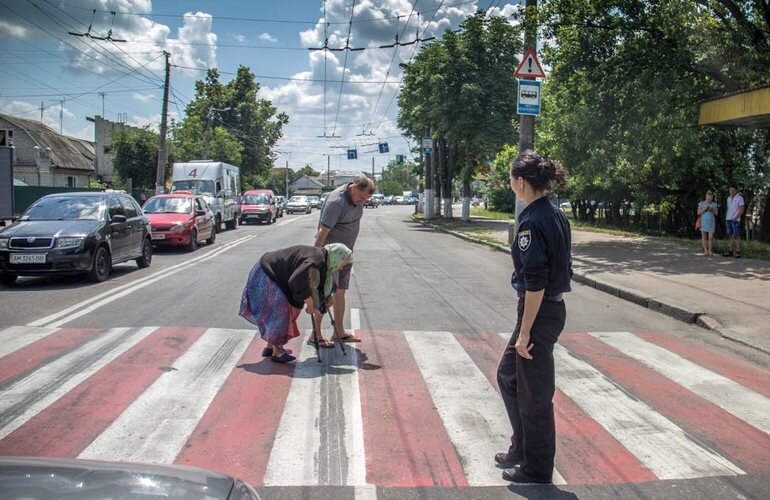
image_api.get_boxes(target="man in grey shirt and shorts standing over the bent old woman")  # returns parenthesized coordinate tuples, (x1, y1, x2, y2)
(313, 175, 374, 342)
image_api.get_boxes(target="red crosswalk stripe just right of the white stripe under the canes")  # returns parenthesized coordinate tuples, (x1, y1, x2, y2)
(359, 331, 464, 487)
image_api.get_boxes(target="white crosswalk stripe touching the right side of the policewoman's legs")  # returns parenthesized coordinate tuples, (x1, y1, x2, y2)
(554, 344, 743, 479)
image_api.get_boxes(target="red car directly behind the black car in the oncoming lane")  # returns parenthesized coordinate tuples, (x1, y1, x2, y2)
(142, 191, 217, 251)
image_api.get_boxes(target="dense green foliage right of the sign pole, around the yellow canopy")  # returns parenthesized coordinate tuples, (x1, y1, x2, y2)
(537, 0, 770, 238)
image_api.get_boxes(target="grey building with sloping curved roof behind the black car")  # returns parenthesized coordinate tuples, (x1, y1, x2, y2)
(0, 113, 94, 188)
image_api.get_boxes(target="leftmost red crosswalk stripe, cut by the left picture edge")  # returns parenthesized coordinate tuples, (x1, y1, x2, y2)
(0, 328, 102, 385)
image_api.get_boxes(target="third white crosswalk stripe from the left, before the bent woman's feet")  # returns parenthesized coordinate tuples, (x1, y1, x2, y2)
(78, 328, 255, 463)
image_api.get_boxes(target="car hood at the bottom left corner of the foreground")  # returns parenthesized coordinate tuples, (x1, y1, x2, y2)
(0, 457, 257, 500)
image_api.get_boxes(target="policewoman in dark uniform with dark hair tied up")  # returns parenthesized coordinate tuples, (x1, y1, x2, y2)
(495, 151, 572, 483)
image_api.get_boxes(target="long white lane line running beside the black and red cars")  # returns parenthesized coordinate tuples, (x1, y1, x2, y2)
(27, 235, 256, 327)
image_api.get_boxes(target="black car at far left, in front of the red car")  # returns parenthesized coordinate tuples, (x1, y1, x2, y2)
(0, 192, 152, 285)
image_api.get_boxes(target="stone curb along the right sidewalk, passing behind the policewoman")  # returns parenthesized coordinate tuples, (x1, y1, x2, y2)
(411, 215, 770, 355)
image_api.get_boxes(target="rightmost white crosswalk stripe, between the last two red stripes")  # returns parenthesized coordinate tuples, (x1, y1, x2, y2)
(591, 332, 770, 434)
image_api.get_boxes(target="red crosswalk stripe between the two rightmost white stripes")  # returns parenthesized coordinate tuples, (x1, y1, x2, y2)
(562, 334, 770, 472)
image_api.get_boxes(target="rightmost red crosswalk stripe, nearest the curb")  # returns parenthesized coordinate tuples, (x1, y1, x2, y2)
(636, 332, 770, 398)
